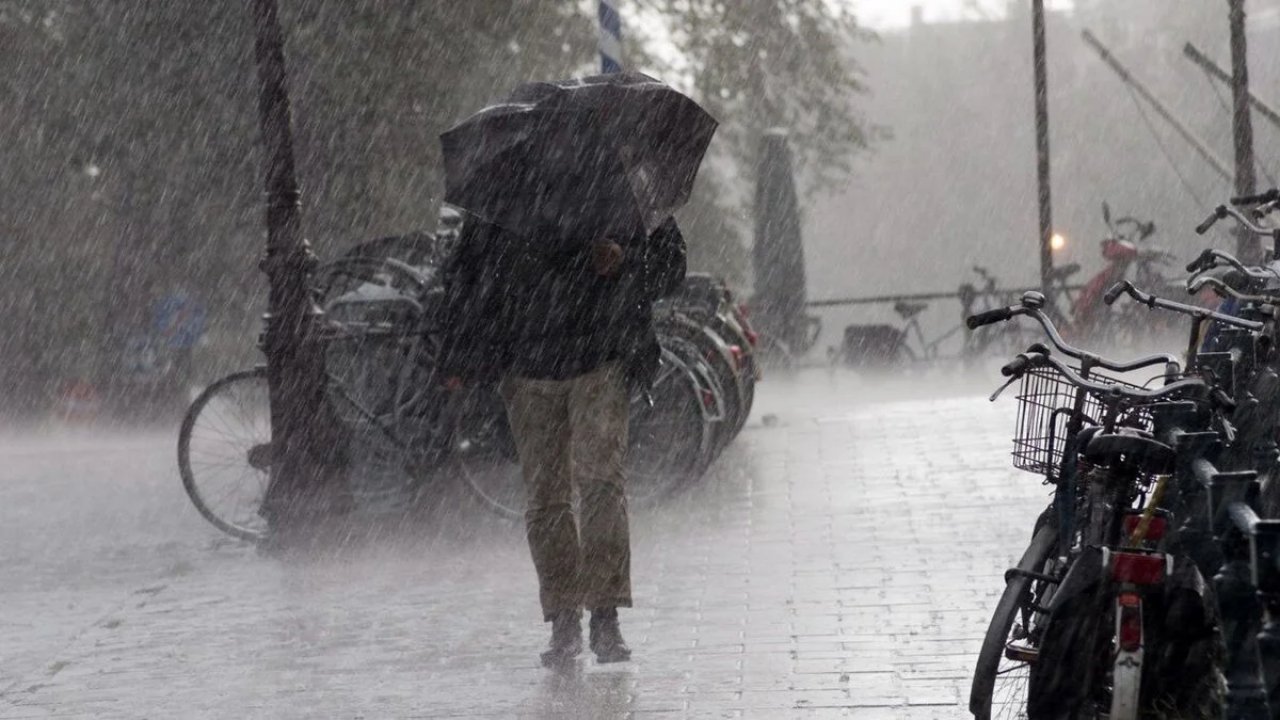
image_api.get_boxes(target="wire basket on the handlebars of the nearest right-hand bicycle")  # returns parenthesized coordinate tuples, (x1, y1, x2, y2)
(1012, 368, 1152, 477)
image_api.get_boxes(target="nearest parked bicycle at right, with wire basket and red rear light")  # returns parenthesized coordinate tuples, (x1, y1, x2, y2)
(968, 292, 1220, 720)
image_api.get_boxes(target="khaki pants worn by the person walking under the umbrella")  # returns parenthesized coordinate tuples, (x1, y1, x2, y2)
(502, 363, 631, 620)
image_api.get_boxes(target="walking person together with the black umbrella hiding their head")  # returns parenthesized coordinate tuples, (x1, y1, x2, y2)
(440, 72, 717, 666)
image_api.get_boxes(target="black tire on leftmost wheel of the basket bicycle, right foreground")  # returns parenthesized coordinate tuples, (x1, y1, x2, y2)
(969, 523, 1057, 720)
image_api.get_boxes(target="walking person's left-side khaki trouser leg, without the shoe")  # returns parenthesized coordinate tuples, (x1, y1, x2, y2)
(502, 378, 582, 621)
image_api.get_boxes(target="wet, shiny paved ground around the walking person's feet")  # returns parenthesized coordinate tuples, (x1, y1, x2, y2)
(0, 370, 1047, 720)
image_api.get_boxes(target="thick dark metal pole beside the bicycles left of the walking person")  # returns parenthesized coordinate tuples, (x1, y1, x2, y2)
(253, 0, 324, 533)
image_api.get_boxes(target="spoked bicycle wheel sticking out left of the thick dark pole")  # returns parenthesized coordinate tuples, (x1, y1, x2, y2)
(178, 368, 271, 541)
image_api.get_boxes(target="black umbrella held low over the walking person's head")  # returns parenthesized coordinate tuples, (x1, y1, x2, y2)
(440, 73, 717, 237)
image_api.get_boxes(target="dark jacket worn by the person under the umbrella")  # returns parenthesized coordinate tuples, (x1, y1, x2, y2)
(440, 219, 685, 391)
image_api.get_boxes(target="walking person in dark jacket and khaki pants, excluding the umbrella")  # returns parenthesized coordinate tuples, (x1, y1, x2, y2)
(443, 217, 686, 667)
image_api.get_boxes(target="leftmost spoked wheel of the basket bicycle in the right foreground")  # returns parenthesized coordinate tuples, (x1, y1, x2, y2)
(969, 523, 1057, 720)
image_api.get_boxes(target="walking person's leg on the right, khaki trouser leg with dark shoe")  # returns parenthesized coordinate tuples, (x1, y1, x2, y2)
(568, 363, 631, 662)
